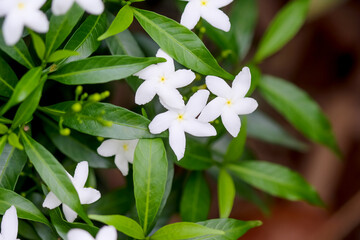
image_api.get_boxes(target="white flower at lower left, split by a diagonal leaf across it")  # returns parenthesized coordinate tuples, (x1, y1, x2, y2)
(43, 161, 101, 222)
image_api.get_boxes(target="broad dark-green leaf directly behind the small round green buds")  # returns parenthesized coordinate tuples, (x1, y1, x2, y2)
(49, 101, 164, 140)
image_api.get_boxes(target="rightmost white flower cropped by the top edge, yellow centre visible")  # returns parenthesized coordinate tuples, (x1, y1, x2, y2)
(180, 0, 233, 32)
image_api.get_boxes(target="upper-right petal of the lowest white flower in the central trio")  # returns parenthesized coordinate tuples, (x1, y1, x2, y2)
(185, 90, 210, 118)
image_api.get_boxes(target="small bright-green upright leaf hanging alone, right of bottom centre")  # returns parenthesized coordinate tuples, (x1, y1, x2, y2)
(218, 169, 236, 218)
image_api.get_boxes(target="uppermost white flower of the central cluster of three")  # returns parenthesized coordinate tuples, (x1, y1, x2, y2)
(134, 49, 196, 108)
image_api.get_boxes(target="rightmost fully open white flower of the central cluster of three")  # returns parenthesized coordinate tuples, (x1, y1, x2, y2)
(199, 67, 258, 137)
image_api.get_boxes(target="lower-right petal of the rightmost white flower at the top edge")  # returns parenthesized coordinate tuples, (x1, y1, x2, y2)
(201, 8, 231, 32)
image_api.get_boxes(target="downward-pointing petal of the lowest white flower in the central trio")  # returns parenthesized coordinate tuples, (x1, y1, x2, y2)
(169, 124, 186, 160)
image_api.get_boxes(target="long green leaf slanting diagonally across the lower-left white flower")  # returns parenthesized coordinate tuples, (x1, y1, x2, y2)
(21, 131, 91, 223)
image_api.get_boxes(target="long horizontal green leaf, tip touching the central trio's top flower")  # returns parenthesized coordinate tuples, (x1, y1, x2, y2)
(49, 56, 165, 85)
